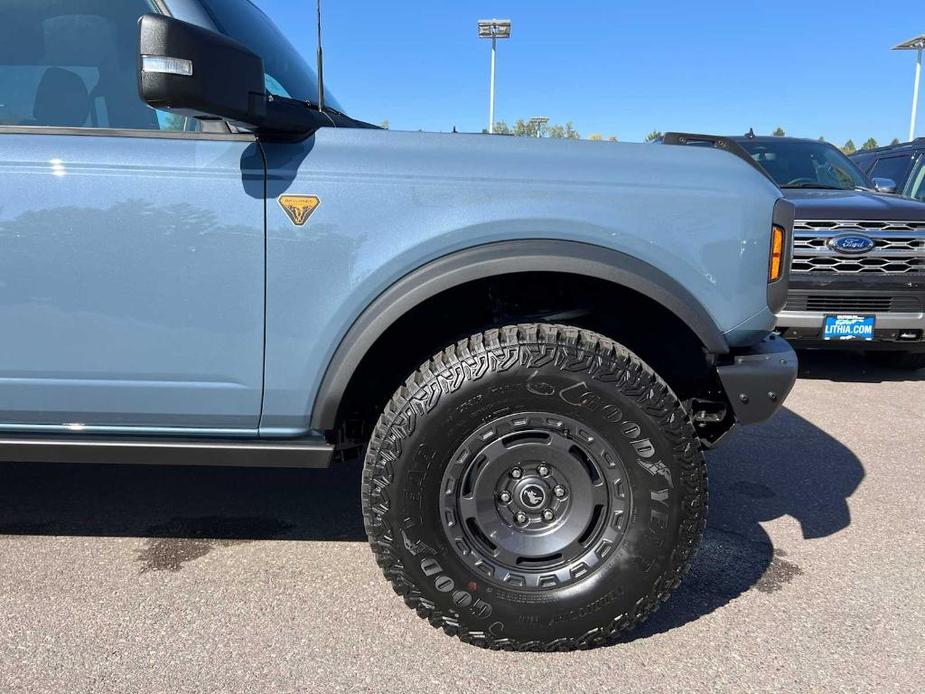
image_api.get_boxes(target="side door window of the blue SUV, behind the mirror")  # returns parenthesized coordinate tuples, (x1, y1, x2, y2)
(0, 0, 198, 130)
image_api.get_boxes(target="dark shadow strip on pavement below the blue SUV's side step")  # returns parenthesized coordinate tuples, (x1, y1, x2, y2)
(0, 461, 366, 548)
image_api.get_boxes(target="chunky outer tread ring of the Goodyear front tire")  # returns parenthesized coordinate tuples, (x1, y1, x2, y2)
(361, 323, 708, 651)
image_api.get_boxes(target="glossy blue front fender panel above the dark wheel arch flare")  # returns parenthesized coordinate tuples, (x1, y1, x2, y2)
(261, 128, 780, 435)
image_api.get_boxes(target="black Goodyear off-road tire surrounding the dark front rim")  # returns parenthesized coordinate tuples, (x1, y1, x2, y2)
(362, 324, 707, 651)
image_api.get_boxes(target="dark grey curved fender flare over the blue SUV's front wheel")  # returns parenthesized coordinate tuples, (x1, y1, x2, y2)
(311, 240, 729, 430)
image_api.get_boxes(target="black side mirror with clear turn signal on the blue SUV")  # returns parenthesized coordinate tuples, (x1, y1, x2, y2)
(138, 14, 330, 137)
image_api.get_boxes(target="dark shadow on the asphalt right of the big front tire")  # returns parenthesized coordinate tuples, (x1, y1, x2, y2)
(628, 408, 864, 640)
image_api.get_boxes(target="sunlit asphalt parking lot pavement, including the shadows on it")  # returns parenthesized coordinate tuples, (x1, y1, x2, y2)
(0, 354, 925, 694)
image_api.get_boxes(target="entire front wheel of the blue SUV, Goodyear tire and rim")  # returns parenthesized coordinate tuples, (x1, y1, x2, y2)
(362, 324, 707, 650)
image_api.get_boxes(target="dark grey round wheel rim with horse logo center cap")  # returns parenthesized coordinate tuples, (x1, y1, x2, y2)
(440, 412, 632, 590)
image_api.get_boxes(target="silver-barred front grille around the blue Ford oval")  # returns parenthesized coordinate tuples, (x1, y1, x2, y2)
(792, 220, 925, 275)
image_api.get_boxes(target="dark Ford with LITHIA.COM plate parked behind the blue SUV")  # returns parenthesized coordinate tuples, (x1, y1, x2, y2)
(731, 135, 925, 369)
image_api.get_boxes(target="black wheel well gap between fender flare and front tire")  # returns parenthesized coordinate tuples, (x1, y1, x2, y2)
(337, 272, 715, 442)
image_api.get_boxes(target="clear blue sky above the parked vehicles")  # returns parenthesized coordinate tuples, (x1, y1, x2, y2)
(255, 0, 925, 146)
